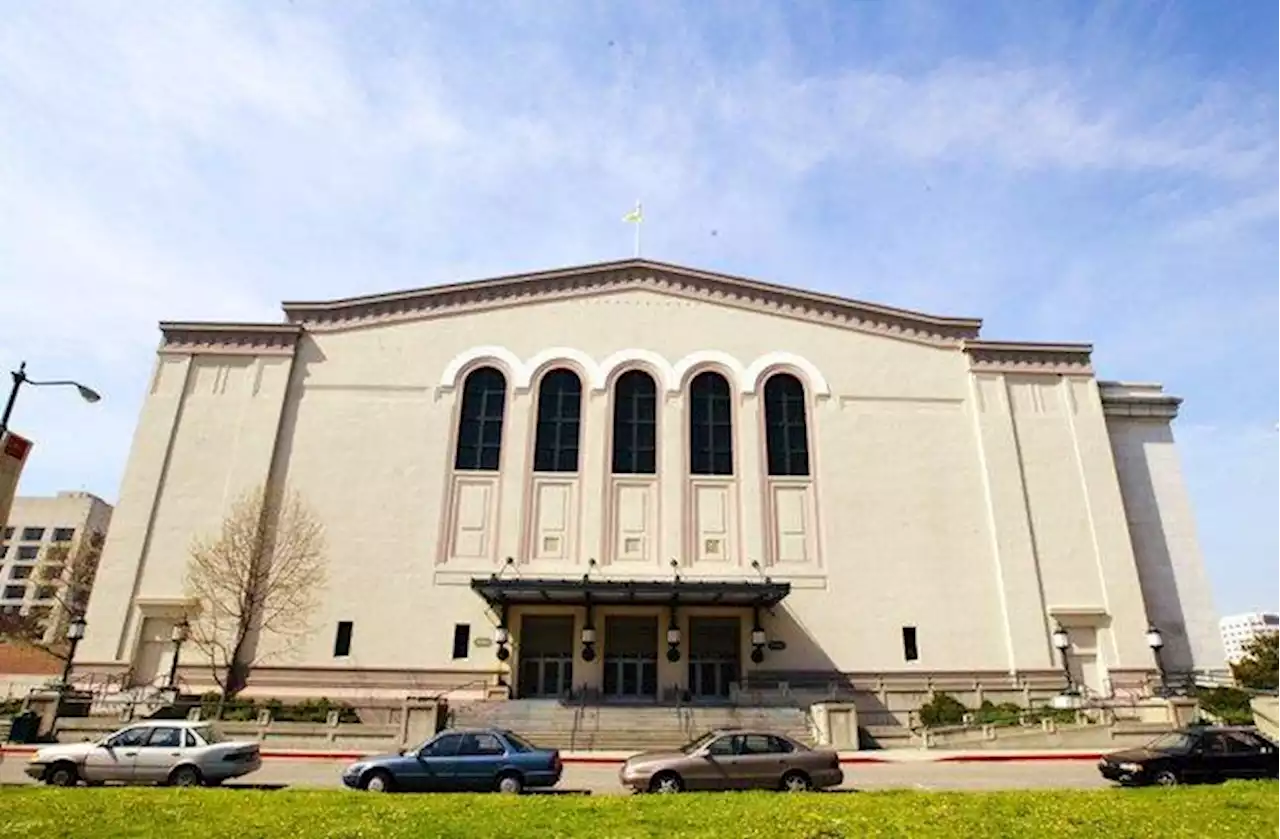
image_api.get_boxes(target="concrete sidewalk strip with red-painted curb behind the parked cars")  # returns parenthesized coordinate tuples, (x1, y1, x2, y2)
(0, 745, 1106, 766)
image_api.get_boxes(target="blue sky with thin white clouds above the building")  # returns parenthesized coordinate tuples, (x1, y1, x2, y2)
(0, 0, 1280, 614)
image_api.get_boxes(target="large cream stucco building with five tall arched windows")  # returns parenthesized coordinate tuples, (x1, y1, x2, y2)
(77, 260, 1222, 701)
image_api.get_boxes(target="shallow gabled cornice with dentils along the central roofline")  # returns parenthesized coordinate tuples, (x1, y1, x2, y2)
(283, 259, 982, 345)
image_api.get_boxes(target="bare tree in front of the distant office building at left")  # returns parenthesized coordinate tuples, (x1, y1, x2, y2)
(0, 532, 102, 661)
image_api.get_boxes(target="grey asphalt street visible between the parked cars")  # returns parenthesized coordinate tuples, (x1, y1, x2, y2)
(0, 754, 1108, 795)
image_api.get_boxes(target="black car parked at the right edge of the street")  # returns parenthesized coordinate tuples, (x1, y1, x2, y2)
(1098, 726, 1280, 786)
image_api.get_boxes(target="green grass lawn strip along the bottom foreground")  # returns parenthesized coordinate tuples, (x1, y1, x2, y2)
(0, 781, 1280, 839)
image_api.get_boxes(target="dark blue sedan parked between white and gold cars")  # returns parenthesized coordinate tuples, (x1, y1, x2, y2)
(342, 729, 564, 794)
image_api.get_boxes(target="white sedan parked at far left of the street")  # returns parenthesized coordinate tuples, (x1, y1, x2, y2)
(26, 720, 262, 786)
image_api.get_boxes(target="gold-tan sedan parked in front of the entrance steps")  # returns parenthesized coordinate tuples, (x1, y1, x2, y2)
(618, 730, 845, 793)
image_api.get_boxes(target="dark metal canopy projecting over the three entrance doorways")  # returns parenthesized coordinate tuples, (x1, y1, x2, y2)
(471, 576, 791, 608)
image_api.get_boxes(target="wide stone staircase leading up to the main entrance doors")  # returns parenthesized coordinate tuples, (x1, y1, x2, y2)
(449, 699, 813, 752)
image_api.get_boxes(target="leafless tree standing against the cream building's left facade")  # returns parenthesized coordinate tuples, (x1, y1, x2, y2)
(187, 487, 325, 701)
